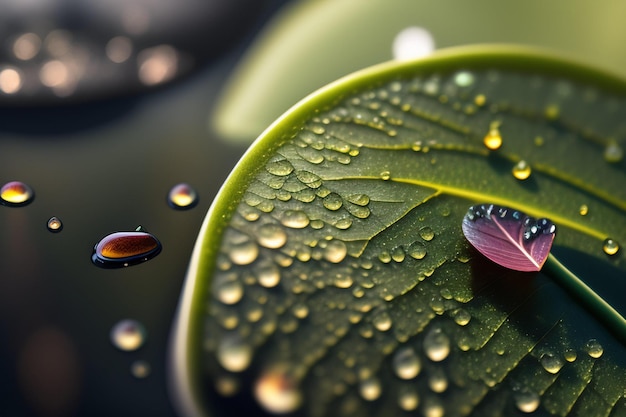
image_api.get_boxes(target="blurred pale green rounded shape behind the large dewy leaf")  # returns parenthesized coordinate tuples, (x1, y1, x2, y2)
(210, 0, 626, 143)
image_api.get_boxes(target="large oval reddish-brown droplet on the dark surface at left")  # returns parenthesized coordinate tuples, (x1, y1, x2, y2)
(91, 226, 161, 268)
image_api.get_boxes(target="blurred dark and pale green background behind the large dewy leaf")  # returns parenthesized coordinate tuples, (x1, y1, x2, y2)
(0, 0, 626, 417)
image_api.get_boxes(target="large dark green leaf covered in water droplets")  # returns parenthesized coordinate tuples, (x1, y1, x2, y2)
(169, 48, 626, 416)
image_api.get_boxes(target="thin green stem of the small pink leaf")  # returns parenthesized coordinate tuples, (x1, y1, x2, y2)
(543, 254, 626, 342)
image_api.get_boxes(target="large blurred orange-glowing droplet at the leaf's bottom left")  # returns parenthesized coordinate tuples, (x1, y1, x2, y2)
(254, 367, 302, 414)
